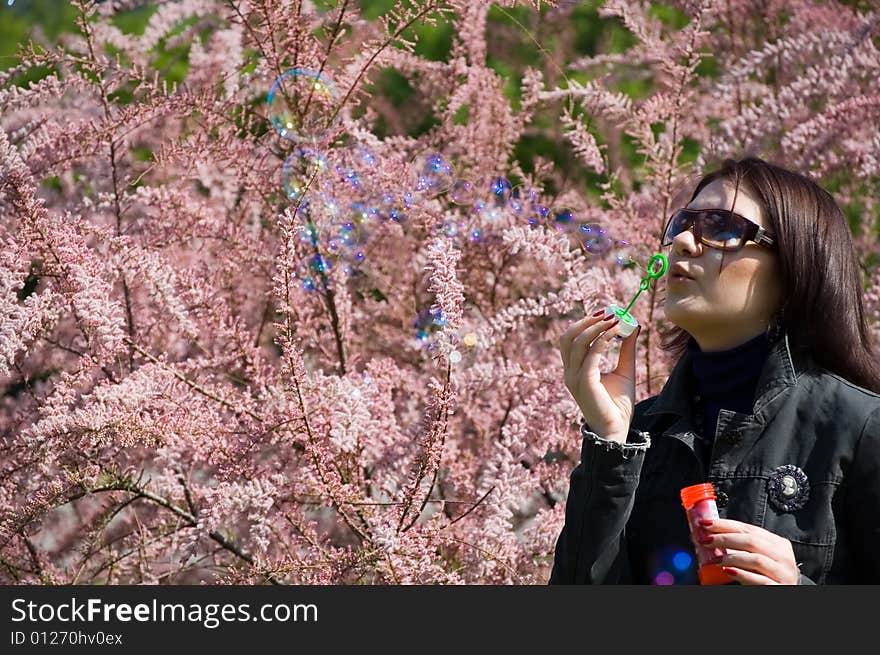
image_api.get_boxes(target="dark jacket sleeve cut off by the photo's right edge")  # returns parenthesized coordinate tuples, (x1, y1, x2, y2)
(844, 407, 880, 584)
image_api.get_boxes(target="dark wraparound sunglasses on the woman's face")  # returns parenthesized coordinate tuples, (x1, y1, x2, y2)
(660, 209, 776, 250)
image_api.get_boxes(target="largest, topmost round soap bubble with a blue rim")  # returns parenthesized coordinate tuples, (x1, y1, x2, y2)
(267, 68, 339, 143)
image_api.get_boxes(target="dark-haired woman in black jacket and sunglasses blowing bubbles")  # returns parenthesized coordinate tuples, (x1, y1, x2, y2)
(550, 157, 880, 584)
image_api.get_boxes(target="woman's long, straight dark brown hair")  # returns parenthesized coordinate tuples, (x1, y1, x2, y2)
(661, 156, 880, 393)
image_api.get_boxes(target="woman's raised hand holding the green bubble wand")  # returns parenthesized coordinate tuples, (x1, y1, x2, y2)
(559, 312, 639, 443)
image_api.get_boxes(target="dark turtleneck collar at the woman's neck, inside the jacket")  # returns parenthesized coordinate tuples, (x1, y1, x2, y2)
(688, 333, 771, 442)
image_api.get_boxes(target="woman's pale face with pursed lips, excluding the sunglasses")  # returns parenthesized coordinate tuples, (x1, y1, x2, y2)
(664, 180, 782, 351)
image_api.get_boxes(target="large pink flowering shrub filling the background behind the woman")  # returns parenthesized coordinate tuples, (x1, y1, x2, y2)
(0, 0, 880, 584)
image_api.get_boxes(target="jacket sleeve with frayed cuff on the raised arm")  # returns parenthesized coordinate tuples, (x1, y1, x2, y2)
(548, 426, 651, 584)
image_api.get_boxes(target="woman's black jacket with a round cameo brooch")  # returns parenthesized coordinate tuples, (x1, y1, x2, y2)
(549, 331, 880, 584)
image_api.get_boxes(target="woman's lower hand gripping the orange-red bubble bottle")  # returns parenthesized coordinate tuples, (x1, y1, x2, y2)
(699, 519, 800, 584)
